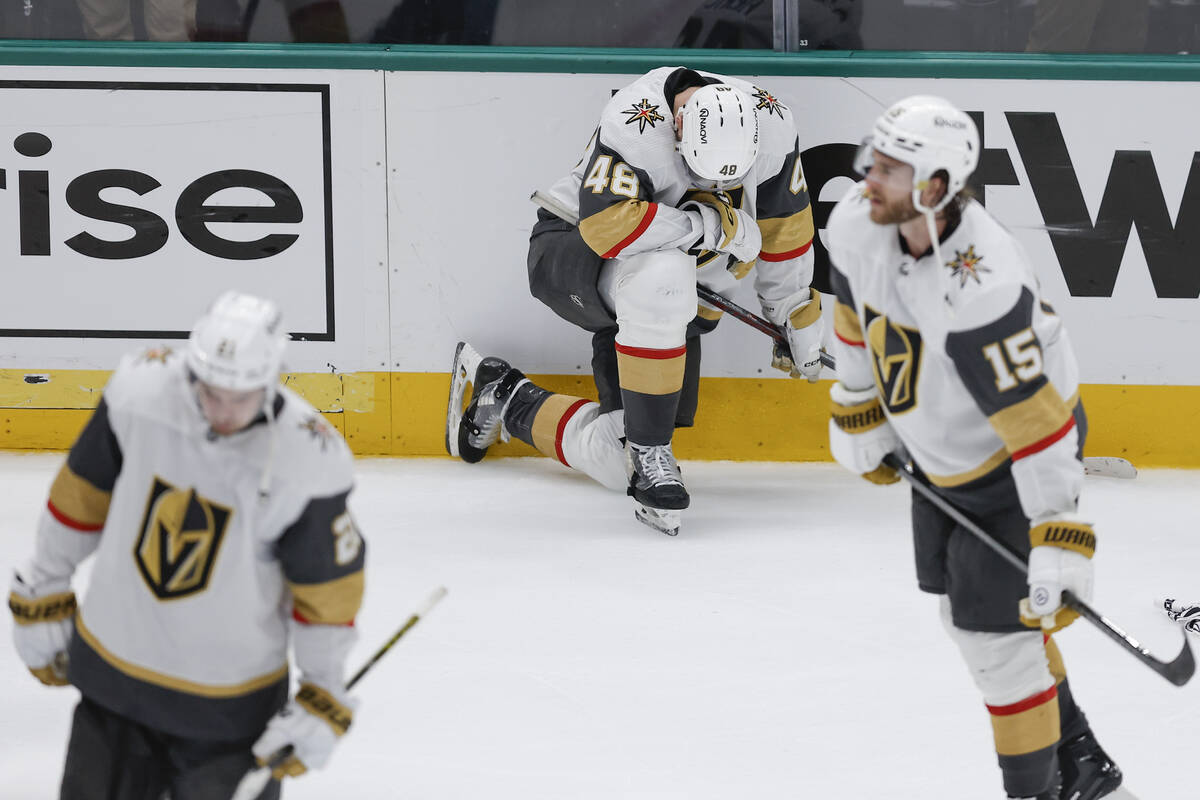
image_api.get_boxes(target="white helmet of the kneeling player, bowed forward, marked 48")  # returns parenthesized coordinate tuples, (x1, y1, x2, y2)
(677, 83, 758, 185)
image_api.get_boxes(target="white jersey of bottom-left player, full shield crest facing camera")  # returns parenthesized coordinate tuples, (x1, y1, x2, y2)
(32, 349, 365, 740)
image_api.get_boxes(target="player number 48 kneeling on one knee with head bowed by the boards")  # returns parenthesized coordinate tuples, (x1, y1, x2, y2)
(446, 67, 821, 534)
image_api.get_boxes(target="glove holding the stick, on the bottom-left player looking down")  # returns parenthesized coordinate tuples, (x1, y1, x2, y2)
(251, 684, 358, 778)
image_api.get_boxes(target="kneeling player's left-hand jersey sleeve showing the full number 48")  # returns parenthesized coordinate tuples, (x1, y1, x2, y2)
(580, 134, 703, 258)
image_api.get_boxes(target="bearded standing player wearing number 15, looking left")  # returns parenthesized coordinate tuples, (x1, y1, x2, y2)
(827, 96, 1121, 800)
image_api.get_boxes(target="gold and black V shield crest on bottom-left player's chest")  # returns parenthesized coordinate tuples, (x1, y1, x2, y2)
(133, 476, 233, 600)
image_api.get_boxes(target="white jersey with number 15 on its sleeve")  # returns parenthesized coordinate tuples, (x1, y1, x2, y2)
(827, 184, 1082, 519)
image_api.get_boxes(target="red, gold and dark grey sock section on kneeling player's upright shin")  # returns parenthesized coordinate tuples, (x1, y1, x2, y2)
(617, 343, 688, 445)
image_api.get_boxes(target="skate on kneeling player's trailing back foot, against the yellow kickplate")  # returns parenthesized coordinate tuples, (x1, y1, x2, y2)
(445, 342, 526, 464)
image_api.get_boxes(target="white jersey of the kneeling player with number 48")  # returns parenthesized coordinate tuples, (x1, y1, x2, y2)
(550, 67, 814, 318)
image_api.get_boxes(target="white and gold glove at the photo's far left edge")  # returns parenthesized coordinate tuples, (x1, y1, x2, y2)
(8, 573, 76, 686)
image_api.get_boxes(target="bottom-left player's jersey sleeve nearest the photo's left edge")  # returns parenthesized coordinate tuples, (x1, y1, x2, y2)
(25, 397, 122, 583)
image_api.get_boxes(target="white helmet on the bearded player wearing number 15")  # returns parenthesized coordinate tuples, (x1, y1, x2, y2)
(854, 95, 979, 211)
